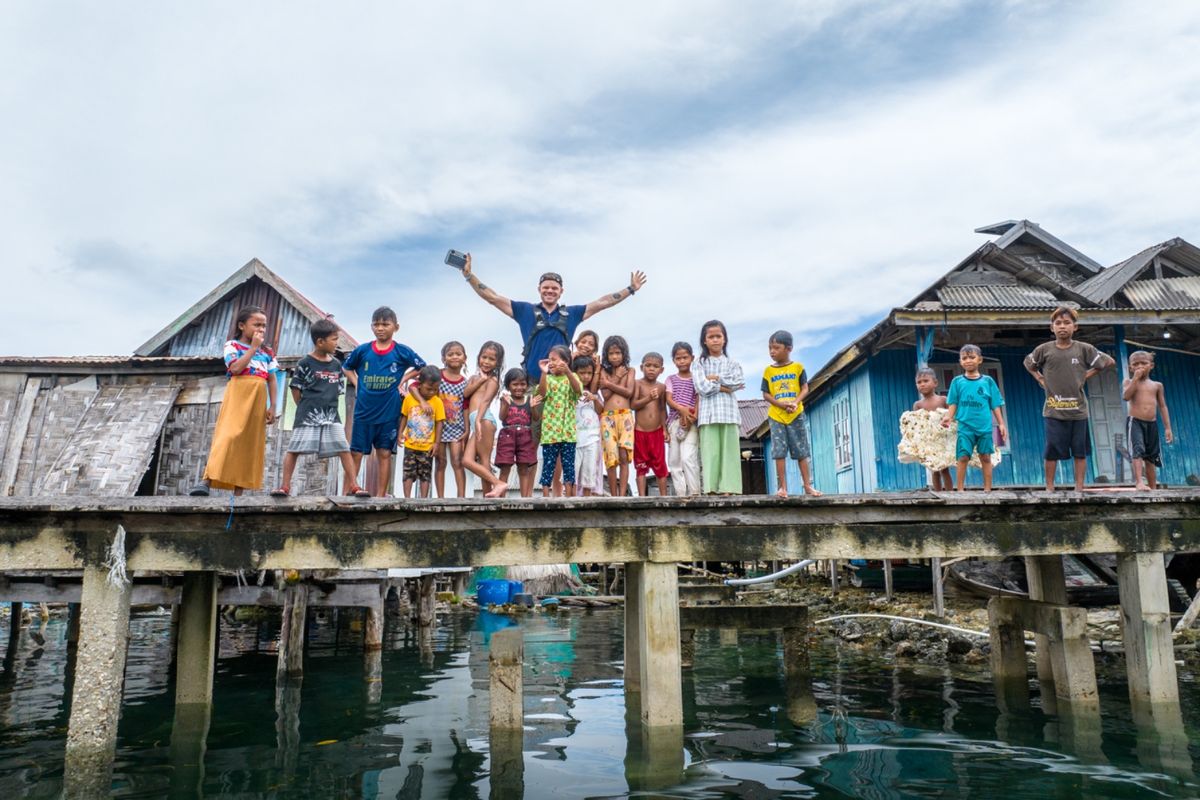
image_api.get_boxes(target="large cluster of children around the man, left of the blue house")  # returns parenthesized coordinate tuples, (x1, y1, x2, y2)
(192, 307, 820, 498)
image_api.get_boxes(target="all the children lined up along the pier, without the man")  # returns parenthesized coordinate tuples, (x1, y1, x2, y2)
(192, 307, 1172, 498)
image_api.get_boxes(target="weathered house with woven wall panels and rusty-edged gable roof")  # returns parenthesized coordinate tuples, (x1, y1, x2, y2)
(0, 259, 356, 495)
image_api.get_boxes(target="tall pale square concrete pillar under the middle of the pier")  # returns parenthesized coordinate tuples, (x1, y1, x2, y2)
(638, 561, 683, 728)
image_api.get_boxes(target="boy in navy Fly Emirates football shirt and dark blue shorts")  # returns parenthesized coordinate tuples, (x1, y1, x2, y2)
(342, 306, 425, 498)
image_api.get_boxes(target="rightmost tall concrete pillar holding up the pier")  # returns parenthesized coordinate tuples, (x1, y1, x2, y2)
(1117, 553, 1180, 718)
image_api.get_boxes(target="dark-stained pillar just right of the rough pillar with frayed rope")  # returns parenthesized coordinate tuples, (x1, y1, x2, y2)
(175, 572, 220, 705)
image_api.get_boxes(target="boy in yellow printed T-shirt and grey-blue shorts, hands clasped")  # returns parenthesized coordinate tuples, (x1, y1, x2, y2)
(762, 331, 821, 498)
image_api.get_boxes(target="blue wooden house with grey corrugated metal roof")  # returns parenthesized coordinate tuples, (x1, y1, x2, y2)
(757, 219, 1200, 493)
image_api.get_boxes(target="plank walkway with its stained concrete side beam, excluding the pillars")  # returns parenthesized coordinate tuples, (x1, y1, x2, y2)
(0, 489, 1200, 571)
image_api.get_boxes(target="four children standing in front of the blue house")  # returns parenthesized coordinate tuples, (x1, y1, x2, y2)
(913, 306, 1174, 492)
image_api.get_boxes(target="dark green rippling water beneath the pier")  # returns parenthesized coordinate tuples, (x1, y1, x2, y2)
(0, 610, 1200, 800)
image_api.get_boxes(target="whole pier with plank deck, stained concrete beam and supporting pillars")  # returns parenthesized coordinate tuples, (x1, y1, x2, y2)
(0, 491, 1200, 796)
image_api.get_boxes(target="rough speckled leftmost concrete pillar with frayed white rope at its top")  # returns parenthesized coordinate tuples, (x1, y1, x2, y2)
(62, 564, 132, 798)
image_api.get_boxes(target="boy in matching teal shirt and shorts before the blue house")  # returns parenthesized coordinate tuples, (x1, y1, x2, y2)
(942, 344, 1008, 492)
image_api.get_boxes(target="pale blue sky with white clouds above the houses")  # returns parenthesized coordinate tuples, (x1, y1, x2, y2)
(0, 0, 1200, 381)
